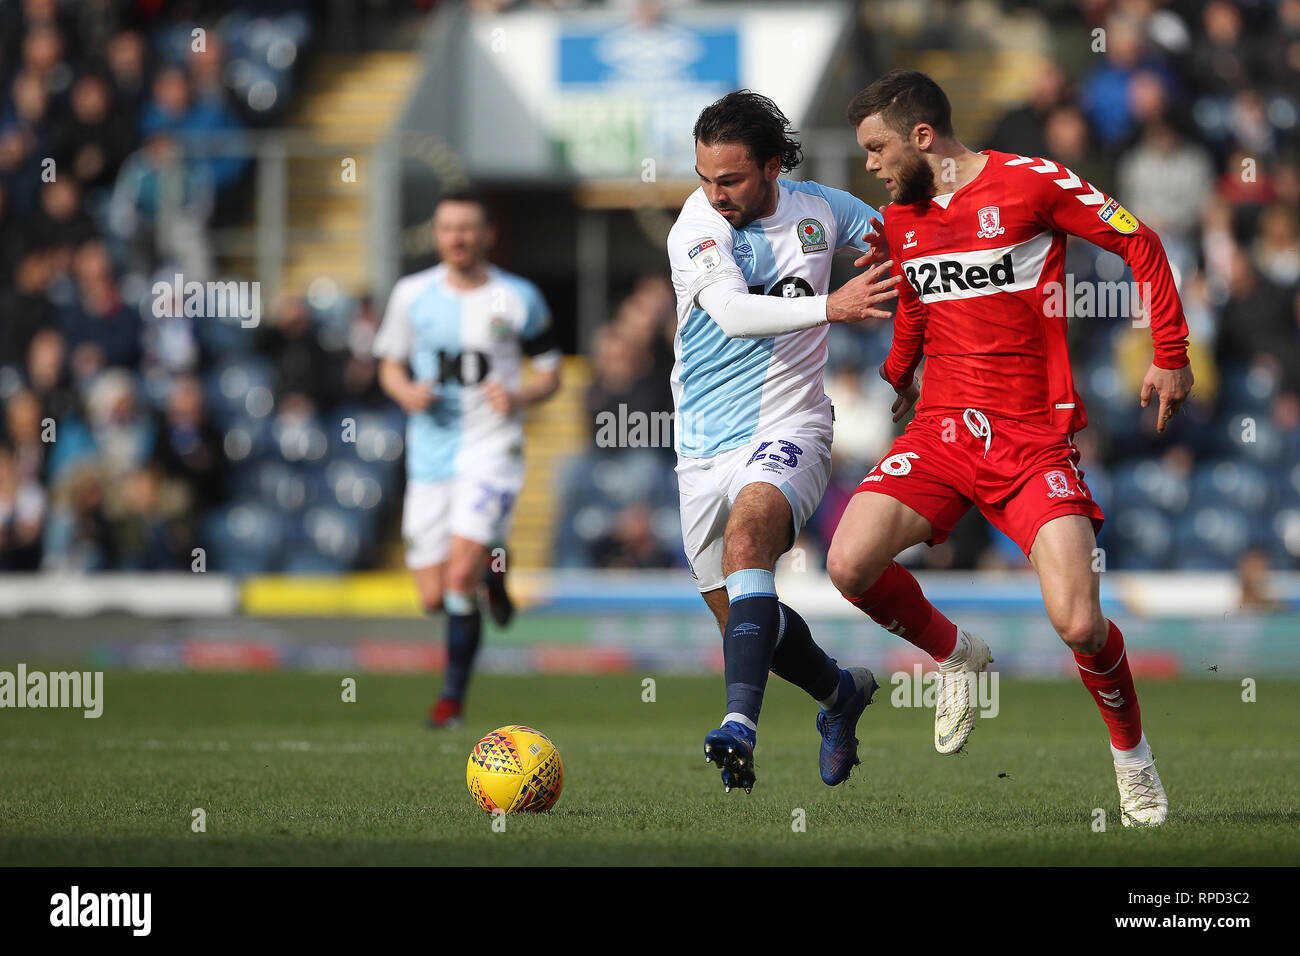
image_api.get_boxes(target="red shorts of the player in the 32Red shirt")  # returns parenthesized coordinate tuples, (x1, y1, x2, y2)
(857, 408, 1105, 557)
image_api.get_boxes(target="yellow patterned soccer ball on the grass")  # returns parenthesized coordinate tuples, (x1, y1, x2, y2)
(465, 723, 564, 813)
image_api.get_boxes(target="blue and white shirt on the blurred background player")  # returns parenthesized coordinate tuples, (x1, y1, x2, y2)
(373, 264, 560, 481)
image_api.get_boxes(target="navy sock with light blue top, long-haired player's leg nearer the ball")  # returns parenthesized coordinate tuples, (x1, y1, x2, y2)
(723, 568, 781, 731)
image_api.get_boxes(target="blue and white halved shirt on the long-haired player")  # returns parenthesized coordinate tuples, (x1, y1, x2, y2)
(668, 179, 879, 458)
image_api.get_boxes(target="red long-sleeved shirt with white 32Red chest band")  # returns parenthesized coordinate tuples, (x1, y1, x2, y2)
(884, 150, 1187, 434)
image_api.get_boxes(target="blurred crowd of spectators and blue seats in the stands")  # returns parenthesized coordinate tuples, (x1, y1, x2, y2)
(0, 0, 1300, 571)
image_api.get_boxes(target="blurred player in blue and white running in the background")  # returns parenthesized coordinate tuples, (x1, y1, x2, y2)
(374, 193, 560, 727)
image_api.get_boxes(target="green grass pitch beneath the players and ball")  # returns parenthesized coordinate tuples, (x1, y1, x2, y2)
(0, 672, 1300, 866)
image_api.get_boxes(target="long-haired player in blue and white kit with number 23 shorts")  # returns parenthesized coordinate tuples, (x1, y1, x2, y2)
(668, 90, 898, 791)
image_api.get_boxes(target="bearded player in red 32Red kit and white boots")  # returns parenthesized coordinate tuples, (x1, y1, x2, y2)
(827, 70, 1192, 826)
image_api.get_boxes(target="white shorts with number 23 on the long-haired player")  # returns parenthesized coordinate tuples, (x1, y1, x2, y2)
(677, 421, 832, 592)
